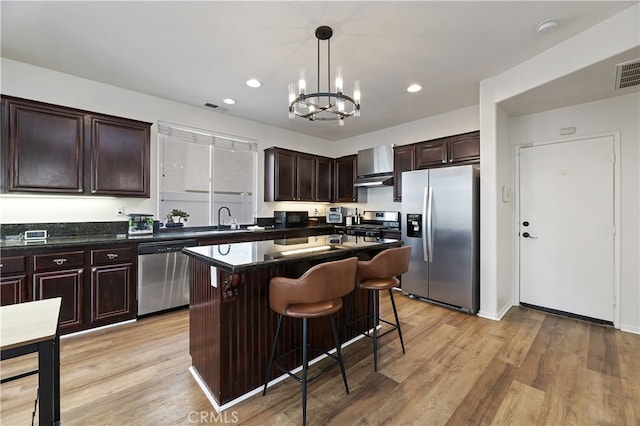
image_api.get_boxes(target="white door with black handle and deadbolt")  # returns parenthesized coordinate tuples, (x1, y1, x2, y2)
(519, 136, 615, 323)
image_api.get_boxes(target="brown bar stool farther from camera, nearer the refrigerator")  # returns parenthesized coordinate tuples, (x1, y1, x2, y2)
(343, 246, 411, 371)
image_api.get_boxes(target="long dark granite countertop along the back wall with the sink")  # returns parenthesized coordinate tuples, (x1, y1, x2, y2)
(0, 225, 333, 249)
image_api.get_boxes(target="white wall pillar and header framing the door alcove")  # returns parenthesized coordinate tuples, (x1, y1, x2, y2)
(479, 4, 640, 332)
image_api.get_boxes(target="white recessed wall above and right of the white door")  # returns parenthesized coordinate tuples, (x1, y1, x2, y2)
(510, 93, 640, 333)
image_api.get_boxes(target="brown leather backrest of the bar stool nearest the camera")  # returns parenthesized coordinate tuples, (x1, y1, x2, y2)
(269, 257, 358, 313)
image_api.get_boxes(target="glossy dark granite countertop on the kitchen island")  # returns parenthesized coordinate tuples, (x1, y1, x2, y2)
(182, 234, 402, 274)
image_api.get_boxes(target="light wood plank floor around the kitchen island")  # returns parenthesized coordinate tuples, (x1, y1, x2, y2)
(0, 294, 640, 426)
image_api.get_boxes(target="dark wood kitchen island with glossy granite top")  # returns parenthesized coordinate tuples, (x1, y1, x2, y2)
(183, 235, 402, 410)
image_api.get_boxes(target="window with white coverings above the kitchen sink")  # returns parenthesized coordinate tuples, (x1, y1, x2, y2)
(158, 122, 258, 227)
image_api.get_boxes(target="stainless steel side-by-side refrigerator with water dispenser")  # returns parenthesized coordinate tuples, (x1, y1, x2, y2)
(401, 165, 480, 314)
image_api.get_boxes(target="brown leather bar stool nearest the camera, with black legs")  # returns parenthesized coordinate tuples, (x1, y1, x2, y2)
(262, 257, 358, 425)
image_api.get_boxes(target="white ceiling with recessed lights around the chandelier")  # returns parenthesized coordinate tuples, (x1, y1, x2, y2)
(0, 0, 640, 141)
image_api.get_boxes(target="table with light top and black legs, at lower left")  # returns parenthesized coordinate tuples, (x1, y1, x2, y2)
(0, 297, 62, 425)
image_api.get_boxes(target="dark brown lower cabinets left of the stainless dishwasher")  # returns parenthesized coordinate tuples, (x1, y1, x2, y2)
(12, 244, 137, 334)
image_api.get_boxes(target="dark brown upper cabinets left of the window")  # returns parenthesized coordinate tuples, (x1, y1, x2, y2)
(1, 96, 151, 198)
